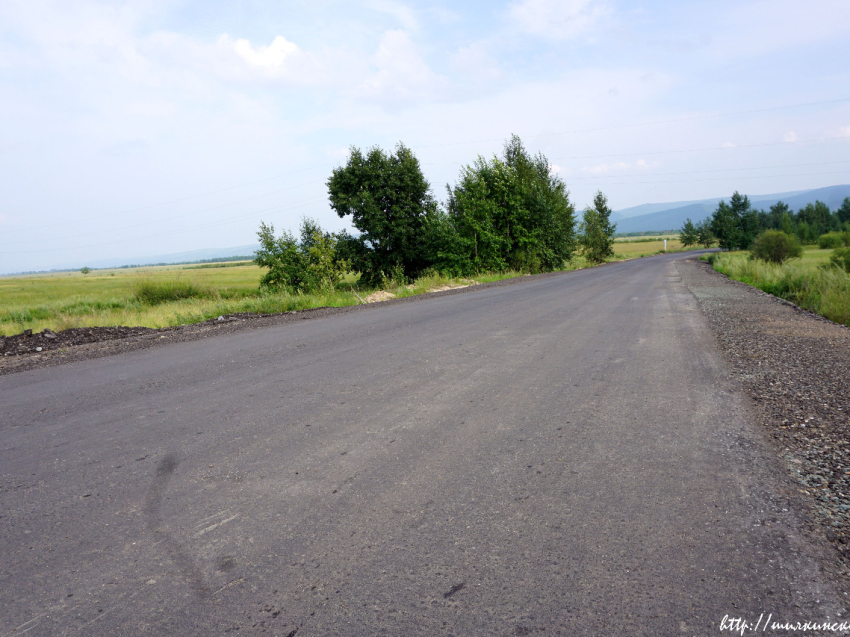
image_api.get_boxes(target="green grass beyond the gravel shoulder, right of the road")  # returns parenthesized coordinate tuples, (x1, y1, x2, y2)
(713, 246, 850, 325)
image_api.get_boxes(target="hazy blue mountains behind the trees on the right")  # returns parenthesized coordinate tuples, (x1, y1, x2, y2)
(611, 185, 850, 232)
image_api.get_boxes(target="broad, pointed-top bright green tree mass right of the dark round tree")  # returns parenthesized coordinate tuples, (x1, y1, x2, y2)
(438, 135, 575, 272)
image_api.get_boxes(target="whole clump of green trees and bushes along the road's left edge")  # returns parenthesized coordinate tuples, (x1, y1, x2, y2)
(255, 136, 615, 291)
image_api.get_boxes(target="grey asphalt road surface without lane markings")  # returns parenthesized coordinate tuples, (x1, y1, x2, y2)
(0, 255, 846, 637)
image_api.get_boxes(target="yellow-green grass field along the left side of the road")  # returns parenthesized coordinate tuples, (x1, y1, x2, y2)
(0, 241, 696, 335)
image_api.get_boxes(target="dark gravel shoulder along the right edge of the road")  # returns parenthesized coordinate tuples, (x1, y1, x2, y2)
(677, 261, 850, 567)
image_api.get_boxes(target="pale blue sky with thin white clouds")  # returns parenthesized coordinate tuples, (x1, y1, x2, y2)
(0, 0, 850, 272)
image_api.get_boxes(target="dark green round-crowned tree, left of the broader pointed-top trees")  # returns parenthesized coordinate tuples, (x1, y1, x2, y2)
(327, 143, 437, 284)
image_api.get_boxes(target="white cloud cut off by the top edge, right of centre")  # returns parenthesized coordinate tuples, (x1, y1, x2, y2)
(510, 0, 608, 40)
